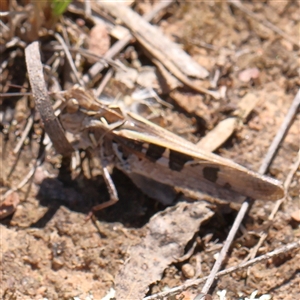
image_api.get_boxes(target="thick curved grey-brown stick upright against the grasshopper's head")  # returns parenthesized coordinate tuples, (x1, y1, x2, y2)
(25, 42, 74, 156)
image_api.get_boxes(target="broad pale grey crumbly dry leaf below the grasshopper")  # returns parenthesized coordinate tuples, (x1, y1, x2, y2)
(115, 201, 213, 300)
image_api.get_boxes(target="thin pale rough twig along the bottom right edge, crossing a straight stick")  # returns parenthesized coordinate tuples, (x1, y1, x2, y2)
(143, 241, 300, 300)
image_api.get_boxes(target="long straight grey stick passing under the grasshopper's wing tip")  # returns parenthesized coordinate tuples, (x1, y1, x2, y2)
(201, 90, 300, 294)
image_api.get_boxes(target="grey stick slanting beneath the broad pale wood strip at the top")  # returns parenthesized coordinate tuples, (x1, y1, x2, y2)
(83, 0, 174, 83)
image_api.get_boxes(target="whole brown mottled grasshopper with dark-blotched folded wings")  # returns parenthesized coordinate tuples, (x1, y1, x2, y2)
(60, 87, 284, 210)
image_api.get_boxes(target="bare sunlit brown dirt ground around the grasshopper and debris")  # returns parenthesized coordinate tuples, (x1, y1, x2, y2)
(0, 1, 300, 300)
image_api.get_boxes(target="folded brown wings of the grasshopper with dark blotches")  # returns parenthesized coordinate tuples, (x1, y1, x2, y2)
(113, 113, 284, 200)
